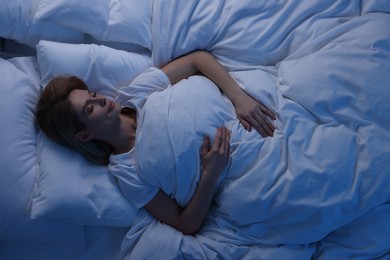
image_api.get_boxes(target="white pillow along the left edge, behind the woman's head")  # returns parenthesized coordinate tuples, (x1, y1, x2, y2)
(0, 57, 85, 248)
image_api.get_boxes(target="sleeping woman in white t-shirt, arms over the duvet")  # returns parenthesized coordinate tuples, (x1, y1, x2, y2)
(37, 51, 275, 234)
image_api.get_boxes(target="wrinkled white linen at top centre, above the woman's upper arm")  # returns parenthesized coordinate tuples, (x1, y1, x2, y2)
(152, 0, 361, 70)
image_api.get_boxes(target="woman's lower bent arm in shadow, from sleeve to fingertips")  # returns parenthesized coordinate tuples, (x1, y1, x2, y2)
(145, 128, 230, 234)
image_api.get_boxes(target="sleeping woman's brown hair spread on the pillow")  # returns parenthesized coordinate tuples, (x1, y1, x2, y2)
(36, 77, 112, 165)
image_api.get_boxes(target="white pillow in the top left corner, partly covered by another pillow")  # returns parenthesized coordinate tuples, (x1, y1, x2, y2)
(0, 0, 85, 47)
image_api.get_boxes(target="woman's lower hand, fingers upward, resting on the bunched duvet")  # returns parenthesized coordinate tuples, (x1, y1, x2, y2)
(201, 127, 230, 181)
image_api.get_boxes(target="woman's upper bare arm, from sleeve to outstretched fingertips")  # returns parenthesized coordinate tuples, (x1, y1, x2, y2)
(162, 51, 276, 136)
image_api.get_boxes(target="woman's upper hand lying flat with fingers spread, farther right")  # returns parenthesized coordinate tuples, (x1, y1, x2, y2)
(234, 92, 276, 137)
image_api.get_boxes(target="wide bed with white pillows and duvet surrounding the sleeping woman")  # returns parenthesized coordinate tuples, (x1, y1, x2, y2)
(0, 0, 390, 259)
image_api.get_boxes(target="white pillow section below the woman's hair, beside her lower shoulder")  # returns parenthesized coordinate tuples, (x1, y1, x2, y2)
(31, 133, 137, 227)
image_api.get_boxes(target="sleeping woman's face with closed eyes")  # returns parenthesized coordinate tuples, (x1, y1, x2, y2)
(69, 89, 121, 139)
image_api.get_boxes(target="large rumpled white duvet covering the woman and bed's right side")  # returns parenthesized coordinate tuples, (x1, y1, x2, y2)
(122, 1, 390, 259)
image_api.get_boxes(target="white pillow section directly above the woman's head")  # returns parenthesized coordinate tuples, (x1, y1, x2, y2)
(37, 41, 152, 96)
